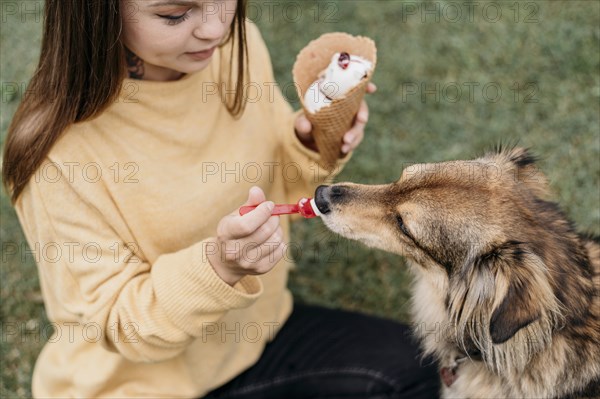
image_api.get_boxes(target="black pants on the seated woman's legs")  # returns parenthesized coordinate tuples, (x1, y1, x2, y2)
(205, 304, 440, 399)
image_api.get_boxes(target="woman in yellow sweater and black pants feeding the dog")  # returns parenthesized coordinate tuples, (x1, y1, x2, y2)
(3, 0, 436, 398)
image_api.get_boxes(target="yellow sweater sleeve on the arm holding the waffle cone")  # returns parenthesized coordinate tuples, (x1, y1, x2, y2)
(248, 24, 352, 202)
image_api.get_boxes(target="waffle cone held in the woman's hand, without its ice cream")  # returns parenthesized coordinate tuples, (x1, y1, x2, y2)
(292, 32, 377, 169)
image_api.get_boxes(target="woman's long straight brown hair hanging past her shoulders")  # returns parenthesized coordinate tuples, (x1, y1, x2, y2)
(2, 0, 248, 203)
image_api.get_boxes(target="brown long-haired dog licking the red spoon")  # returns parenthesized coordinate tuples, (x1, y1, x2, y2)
(315, 146, 600, 398)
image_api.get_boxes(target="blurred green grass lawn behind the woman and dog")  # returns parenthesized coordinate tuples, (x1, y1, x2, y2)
(0, 0, 600, 397)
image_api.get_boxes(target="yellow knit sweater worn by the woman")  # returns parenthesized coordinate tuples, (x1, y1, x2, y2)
(16, 24, 348, 398)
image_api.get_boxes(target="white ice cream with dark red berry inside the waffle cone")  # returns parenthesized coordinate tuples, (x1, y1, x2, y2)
(304, 53, 372, 113)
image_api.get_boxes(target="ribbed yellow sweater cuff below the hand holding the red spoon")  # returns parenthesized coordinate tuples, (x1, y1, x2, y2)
(151, 241, 263, 336)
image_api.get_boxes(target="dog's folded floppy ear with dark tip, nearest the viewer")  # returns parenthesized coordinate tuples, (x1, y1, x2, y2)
(485, 242, 552, 344)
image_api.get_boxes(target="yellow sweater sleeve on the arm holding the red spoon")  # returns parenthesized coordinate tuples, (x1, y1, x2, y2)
(16, 159, 262, 362)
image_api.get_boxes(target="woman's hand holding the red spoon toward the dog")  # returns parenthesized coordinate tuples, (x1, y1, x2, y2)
(208, 187, 284, 286)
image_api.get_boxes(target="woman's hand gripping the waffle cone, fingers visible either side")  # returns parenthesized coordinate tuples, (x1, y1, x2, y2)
(294, 82, 377, 154)
